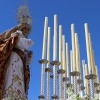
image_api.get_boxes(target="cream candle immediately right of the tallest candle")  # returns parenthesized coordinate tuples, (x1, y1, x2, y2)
(59, 25, 62, 69)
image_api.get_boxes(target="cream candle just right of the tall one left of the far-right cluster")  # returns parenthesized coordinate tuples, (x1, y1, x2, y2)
(75, 33, 79, 72)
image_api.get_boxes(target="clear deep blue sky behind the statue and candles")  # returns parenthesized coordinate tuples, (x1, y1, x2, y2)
(0, 0, 100, 100)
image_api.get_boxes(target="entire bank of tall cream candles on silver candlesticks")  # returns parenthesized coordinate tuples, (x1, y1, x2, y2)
(38, 15, 99, 100)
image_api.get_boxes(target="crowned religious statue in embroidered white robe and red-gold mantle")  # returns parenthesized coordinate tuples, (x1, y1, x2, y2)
(0, 2, 33, 100)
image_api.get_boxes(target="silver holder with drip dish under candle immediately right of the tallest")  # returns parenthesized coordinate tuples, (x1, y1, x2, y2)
(57, 69, 66, 99)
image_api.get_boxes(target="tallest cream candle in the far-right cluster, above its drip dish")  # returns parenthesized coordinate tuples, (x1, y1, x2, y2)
(84, 23, 92, 74)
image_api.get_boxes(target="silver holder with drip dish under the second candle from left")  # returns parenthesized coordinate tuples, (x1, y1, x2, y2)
(45, 68, 52, 100)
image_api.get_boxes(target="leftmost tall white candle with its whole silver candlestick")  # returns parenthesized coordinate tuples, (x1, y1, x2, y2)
(38, 17, 48, 100)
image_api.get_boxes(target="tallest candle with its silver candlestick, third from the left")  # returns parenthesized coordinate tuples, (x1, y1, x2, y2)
(51, 15, 60, 99)
